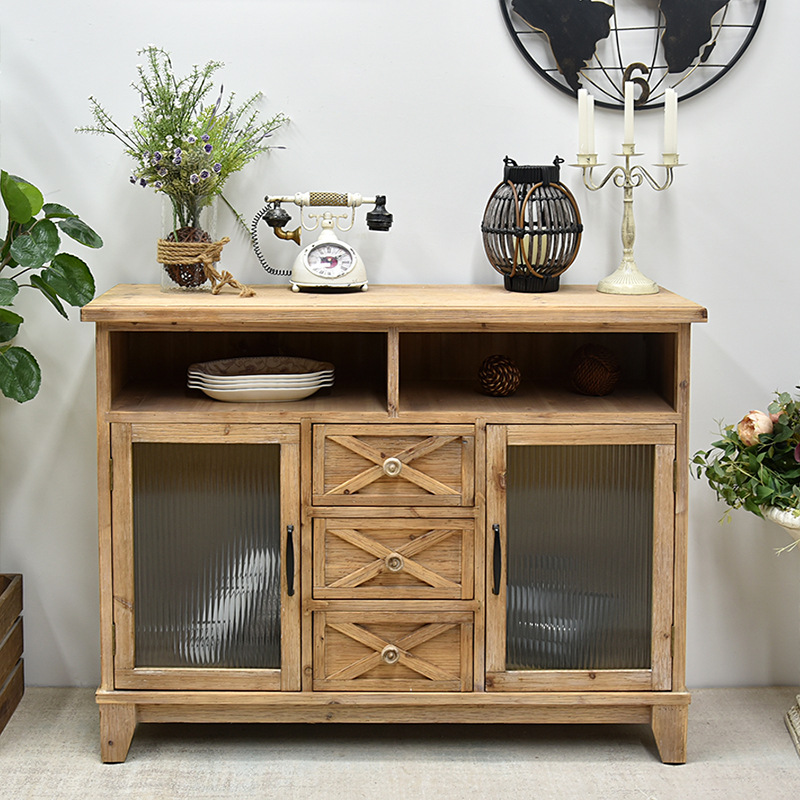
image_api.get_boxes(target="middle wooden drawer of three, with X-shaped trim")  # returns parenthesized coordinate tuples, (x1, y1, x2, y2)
(314, 519, 475, 600)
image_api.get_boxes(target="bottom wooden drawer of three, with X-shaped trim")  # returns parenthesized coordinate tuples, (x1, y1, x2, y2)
(313, 611, 473, 692)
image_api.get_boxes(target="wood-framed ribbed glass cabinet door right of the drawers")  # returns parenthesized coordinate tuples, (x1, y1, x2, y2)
(487, 425, 675, 691)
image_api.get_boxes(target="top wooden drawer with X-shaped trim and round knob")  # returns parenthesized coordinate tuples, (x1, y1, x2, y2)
(313, 425, 475, 506)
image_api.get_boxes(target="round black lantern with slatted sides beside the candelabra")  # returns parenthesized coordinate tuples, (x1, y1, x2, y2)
(481, 156, 583, 292)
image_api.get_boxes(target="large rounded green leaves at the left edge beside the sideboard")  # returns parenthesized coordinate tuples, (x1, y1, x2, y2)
(0, 171, 103, 403)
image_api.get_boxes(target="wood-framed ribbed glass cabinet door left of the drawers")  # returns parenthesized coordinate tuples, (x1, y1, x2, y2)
(112, 424, 300, 690)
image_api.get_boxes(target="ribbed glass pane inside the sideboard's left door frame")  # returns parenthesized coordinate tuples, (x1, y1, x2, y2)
(132, 442, 281, 669)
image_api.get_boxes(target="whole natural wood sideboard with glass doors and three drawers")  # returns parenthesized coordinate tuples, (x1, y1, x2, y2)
(82, 285, 706, 763)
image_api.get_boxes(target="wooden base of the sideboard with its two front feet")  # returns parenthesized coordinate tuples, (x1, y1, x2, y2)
(97, 691, 690, 763)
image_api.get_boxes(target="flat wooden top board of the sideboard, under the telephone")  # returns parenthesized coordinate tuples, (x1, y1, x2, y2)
(81, 284, 707, 330)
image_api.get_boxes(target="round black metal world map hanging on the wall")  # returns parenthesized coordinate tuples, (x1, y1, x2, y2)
(500, 0, 766, 108)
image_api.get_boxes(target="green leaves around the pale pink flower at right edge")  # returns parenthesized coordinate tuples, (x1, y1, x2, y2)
(692, 387, 800, 516)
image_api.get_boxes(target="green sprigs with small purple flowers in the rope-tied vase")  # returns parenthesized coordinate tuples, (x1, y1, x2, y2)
(77, 45, 287, 241)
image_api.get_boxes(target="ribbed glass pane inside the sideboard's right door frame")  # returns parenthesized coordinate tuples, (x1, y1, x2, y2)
(506, 444, 654, 670)
